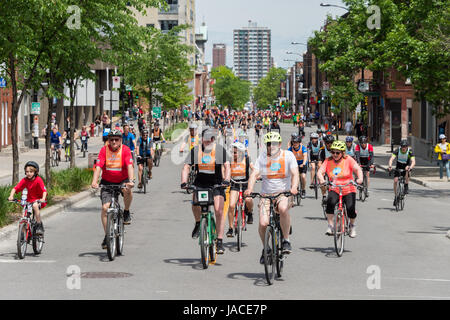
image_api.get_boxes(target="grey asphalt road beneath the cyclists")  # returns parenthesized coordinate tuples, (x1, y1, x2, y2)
(0, 125, 450, 300)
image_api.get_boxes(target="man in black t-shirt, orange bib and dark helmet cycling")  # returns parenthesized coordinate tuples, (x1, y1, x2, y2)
(181, 129, 231, 254)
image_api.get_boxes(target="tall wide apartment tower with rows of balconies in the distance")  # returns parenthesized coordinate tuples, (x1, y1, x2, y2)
(233, 21, 272, 86)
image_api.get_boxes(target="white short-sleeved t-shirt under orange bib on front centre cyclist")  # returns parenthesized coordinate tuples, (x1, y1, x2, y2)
(255, 150, 298, 194)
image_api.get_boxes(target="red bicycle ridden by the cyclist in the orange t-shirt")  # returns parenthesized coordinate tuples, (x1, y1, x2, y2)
(328, 181, 358, 257)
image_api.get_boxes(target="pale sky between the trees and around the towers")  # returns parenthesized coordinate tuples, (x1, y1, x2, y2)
(195, 0, 346, 68)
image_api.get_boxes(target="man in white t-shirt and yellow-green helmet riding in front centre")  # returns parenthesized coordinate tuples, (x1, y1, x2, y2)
(244, 132, 299, 264)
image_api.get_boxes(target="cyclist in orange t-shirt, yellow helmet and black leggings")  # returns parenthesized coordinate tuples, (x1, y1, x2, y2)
(317, 140, 363, 238)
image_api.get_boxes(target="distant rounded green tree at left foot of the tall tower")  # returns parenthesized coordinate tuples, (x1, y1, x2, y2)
(211, 66, 251, 109)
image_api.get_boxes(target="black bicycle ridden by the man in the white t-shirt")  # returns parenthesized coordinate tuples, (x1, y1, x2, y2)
(246, 192, 292, 285)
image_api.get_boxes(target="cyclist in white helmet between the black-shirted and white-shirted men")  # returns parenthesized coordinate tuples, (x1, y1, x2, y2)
(227, 142, 253, 237)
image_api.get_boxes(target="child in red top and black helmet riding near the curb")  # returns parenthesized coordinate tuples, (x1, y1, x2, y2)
(8, 161, 47, 235)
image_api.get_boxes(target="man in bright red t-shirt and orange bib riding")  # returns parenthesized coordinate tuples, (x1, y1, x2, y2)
(91, 130, 134, 249)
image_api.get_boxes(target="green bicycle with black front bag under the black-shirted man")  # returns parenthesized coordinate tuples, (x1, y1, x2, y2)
(187, 185, 223, 269)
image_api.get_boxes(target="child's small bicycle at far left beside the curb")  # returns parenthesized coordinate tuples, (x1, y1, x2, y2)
(11, 199, 44, 259)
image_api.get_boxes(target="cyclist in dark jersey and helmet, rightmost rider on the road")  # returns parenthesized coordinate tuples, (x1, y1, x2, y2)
(389, 140, 416, 201)
